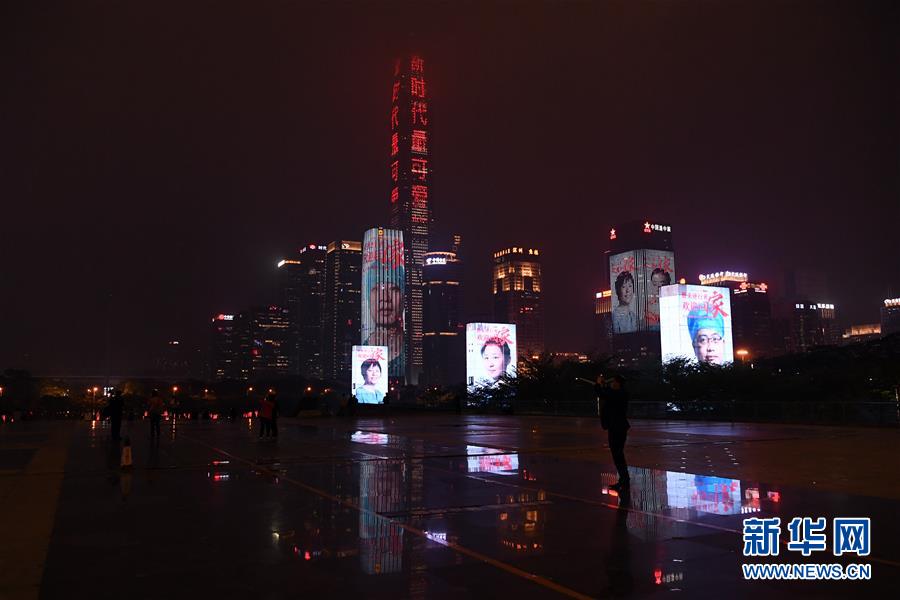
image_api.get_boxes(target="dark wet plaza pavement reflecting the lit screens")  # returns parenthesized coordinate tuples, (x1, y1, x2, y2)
(0, 415, 900, 598)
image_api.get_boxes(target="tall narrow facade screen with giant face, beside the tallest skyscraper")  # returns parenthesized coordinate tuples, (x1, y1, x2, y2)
(360, 227, 406, 377)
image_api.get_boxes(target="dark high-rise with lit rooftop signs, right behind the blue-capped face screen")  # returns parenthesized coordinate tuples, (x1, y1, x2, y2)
(732, 282, 774, 358)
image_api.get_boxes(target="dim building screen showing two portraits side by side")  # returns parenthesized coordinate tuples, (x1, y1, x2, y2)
(609, 249, 675, 334)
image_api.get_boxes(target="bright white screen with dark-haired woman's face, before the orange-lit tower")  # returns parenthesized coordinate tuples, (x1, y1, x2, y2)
(466, 323, 516, 392)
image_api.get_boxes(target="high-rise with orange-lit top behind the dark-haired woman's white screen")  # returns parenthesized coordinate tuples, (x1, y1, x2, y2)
(493, 246, 545, 361)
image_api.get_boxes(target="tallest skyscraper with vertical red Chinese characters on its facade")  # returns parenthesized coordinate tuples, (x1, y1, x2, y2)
(389, 55, 432, 384)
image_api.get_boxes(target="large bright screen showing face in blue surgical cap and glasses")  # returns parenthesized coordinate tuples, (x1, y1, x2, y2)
(659, 285, 734, 365)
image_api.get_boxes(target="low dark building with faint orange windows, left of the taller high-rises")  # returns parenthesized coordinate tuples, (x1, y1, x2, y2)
(246, 306, 291, 377)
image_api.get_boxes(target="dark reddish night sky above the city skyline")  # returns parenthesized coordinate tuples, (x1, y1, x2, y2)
(0, 0, 900, 374)
